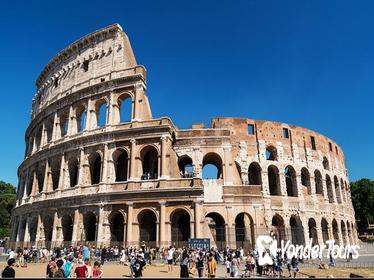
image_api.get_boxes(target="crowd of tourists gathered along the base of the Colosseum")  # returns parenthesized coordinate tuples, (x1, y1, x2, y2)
(3, 245, 310, 278)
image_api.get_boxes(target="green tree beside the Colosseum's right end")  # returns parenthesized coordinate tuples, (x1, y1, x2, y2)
(351, 178, 374, 228)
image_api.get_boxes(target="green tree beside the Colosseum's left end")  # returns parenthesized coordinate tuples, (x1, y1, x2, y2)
(0, 181, 17, 237)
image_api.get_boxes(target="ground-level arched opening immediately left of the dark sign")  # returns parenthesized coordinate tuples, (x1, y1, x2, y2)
(170, 209, 190, 248)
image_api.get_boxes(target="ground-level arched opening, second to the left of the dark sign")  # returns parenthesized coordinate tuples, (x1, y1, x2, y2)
(138, 210, 157, 246)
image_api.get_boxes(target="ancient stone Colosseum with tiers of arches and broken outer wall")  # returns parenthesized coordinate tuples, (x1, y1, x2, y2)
(11, 24, 357, 248)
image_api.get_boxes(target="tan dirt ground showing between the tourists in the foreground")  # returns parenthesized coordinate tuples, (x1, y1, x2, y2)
(0, 263, 374, 278)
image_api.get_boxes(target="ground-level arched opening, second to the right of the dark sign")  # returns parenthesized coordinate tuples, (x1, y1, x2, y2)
(235, 213, 255, 250)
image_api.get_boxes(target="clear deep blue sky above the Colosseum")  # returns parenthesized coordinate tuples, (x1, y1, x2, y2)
(0, 0, 374, 184)
